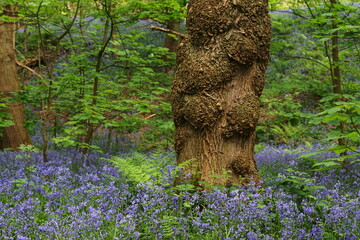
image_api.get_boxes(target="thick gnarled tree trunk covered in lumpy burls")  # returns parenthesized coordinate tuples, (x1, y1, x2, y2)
(172, 0, 271, 186)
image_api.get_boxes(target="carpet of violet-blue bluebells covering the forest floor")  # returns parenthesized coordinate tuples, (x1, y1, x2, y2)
(0, 143, 360, 240)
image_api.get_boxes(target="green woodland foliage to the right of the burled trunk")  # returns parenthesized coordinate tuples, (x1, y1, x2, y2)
(257, 1, 360, 144)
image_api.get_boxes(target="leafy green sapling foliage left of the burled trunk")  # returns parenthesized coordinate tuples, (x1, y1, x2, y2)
(17, 1, 176, 150)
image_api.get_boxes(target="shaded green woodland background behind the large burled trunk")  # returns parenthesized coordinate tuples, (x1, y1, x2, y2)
(0, 0, 360, 158)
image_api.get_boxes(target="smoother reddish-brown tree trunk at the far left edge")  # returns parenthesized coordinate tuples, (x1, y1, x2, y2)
(0, 7, 31, 150)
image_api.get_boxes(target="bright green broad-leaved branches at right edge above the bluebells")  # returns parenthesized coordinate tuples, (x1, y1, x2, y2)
(302, 95, 360, 177)
